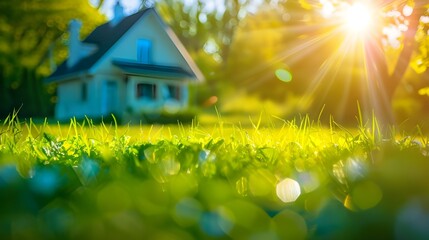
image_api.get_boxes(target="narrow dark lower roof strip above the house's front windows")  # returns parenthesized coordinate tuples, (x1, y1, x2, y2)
(113, 59, 195, 78)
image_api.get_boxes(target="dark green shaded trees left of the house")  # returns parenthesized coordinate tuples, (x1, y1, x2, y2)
(0, 0, 104, 117)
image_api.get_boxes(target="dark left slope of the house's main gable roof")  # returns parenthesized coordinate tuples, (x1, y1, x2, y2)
(46, 8, 150, 82)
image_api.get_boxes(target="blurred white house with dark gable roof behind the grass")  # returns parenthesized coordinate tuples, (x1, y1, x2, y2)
(46, 1, 204, 120)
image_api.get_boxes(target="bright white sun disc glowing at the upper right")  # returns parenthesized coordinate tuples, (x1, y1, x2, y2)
(343, 2, 374, 34)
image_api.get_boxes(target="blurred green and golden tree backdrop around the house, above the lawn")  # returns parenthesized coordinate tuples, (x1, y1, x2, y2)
(0, 0, 429, 124)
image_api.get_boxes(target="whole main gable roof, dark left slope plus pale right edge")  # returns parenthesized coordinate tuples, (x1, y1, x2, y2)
(46, 8, 204, 82)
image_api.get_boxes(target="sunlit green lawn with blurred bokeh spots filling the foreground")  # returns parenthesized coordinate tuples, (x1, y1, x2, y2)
(0, 113, 429, 239)
